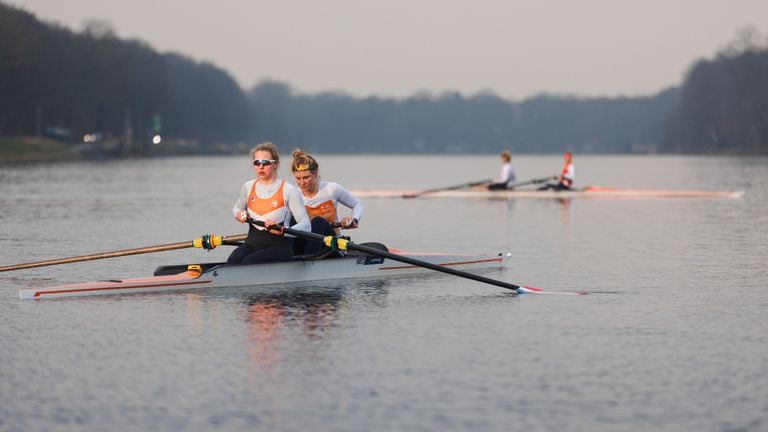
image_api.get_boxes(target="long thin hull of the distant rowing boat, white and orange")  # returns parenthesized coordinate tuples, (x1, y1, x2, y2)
(351, 186, 744, 199)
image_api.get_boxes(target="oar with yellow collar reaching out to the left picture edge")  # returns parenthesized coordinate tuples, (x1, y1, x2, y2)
(0, 234, 247, 272)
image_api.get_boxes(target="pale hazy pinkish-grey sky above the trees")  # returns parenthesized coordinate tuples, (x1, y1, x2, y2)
(3, 0, 768, 100)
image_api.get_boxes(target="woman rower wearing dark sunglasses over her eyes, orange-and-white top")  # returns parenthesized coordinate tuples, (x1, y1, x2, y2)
(227, 142, 310, 264)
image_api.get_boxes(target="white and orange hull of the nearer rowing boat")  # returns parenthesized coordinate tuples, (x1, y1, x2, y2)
(19, 251, 509, 300)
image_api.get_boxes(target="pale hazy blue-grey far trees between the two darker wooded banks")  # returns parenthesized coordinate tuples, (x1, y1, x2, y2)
(249, 82, 679, 153)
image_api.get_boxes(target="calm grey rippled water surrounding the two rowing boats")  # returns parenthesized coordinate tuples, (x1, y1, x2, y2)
(0, 155, 768, 432)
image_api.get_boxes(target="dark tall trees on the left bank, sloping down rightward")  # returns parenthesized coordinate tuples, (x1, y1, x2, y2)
(0, 3, 249, 150)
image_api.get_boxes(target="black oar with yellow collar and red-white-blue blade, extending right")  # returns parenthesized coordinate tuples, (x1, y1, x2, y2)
(255, 219, 586, 295)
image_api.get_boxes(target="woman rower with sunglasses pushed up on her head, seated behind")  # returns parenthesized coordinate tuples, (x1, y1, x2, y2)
(291, 149, 363, 255)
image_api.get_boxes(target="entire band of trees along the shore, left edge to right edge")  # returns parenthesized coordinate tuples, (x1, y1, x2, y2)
(0, 2, 768, 154)
